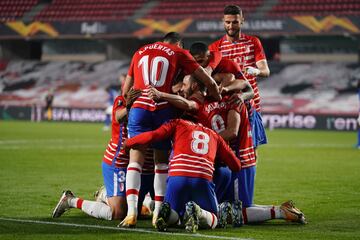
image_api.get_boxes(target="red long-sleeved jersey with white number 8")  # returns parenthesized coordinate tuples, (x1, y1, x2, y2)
(126, 119, 240, 181)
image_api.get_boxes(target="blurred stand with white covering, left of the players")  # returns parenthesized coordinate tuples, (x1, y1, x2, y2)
(0, 61, 129, 108)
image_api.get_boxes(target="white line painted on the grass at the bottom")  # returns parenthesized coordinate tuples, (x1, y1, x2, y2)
(0, 217, 252, 240)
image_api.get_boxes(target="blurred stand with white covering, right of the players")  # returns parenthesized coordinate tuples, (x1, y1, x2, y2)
(259, 63, 360, 114)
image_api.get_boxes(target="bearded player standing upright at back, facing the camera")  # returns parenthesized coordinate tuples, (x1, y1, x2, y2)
(209, 5, 270, 147)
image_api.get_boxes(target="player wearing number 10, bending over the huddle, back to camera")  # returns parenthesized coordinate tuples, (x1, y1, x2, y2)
(120, 32, 221, 227)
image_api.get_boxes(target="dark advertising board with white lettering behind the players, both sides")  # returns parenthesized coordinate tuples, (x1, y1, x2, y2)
(0, 105, 357, 131)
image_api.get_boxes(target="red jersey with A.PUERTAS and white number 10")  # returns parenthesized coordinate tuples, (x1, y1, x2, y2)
(128, 42, 199, 111)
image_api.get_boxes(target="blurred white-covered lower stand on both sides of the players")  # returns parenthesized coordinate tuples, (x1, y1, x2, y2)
(0, 60, 360, 114)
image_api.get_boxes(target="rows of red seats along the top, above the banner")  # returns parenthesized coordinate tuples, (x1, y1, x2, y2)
(0, 0, 360, 22)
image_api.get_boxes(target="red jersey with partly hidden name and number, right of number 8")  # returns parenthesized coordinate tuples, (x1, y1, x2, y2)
(196, 96, 256, 168)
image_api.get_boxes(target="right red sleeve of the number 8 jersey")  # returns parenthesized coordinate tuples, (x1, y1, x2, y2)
(216, 136, 241, 172)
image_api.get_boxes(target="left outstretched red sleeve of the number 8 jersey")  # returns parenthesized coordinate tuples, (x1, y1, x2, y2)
(125, 120, 177, 148)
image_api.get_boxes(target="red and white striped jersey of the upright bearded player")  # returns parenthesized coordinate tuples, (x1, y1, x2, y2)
(209, 34, 266, 111)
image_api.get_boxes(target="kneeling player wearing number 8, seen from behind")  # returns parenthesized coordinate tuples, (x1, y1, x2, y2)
(125, 119, 241, 231)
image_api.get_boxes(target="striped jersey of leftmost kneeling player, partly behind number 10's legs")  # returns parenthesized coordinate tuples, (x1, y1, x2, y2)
(103, 96, 154, 174)
